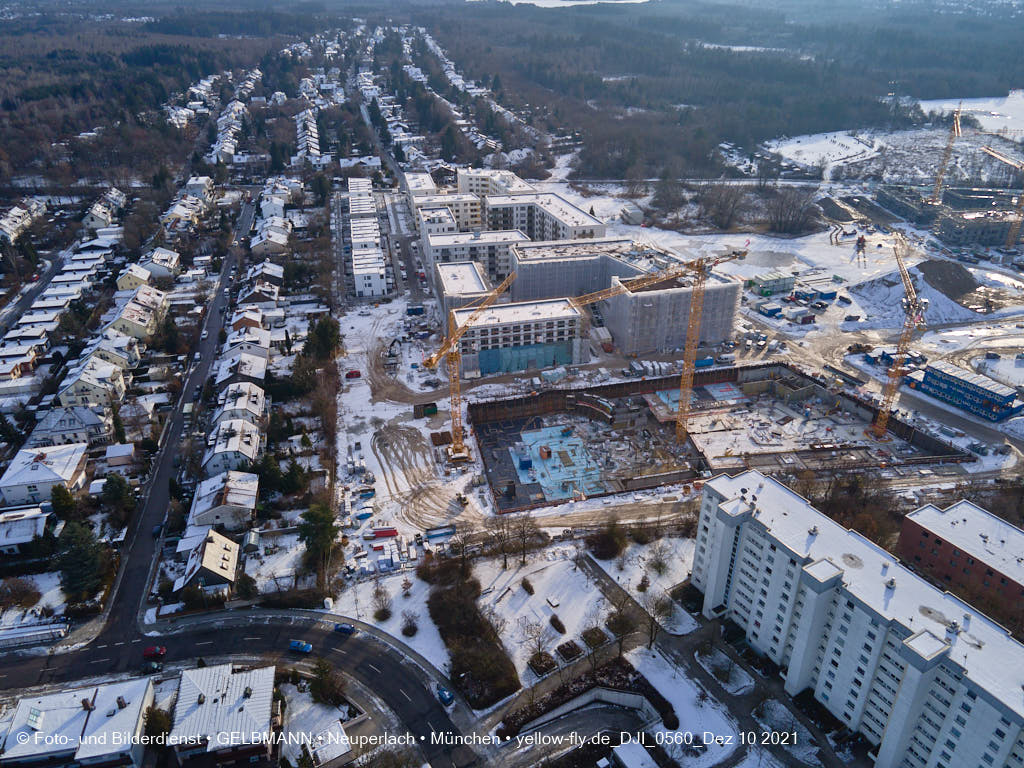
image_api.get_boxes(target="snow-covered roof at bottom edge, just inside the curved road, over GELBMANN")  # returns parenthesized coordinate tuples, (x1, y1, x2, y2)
(169, 664, 274, 752)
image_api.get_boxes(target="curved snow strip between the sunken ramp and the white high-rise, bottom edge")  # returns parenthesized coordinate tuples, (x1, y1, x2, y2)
(627, 648, 738, 768)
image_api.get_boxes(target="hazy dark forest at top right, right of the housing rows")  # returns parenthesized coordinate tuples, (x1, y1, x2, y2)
(417, 0, 1024, 178)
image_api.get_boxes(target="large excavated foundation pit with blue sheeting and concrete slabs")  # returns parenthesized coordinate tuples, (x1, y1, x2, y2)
(469, 362, 975, 512)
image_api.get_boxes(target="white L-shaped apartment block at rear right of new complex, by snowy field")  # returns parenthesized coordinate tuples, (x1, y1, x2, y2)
(483, 193, 605, 241)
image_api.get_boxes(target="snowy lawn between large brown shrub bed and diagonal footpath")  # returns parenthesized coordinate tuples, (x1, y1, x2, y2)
(473, 547, 611, 685)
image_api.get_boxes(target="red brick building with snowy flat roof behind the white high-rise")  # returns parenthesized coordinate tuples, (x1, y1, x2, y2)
(897, 501, 1024, 604)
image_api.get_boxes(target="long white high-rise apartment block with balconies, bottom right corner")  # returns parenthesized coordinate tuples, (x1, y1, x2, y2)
(692, 470, 1024, 768)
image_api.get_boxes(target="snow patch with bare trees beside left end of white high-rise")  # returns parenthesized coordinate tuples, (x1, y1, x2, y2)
(594, 537, 697, 635)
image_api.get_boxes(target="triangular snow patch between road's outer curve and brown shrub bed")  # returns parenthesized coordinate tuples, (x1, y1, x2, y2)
(321, 572, 449, 670)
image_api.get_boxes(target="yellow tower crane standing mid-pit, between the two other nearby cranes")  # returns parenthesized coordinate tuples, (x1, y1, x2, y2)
(569, 251, 746, 442)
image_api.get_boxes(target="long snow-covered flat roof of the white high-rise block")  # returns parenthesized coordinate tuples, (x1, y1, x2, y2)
(707, 470, 1024, 717)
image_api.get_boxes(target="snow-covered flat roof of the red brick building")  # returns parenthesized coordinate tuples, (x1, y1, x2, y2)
(907, 499, 1024, 584)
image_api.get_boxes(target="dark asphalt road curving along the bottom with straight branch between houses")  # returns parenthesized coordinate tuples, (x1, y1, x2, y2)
(0, 203, 478, 768)
